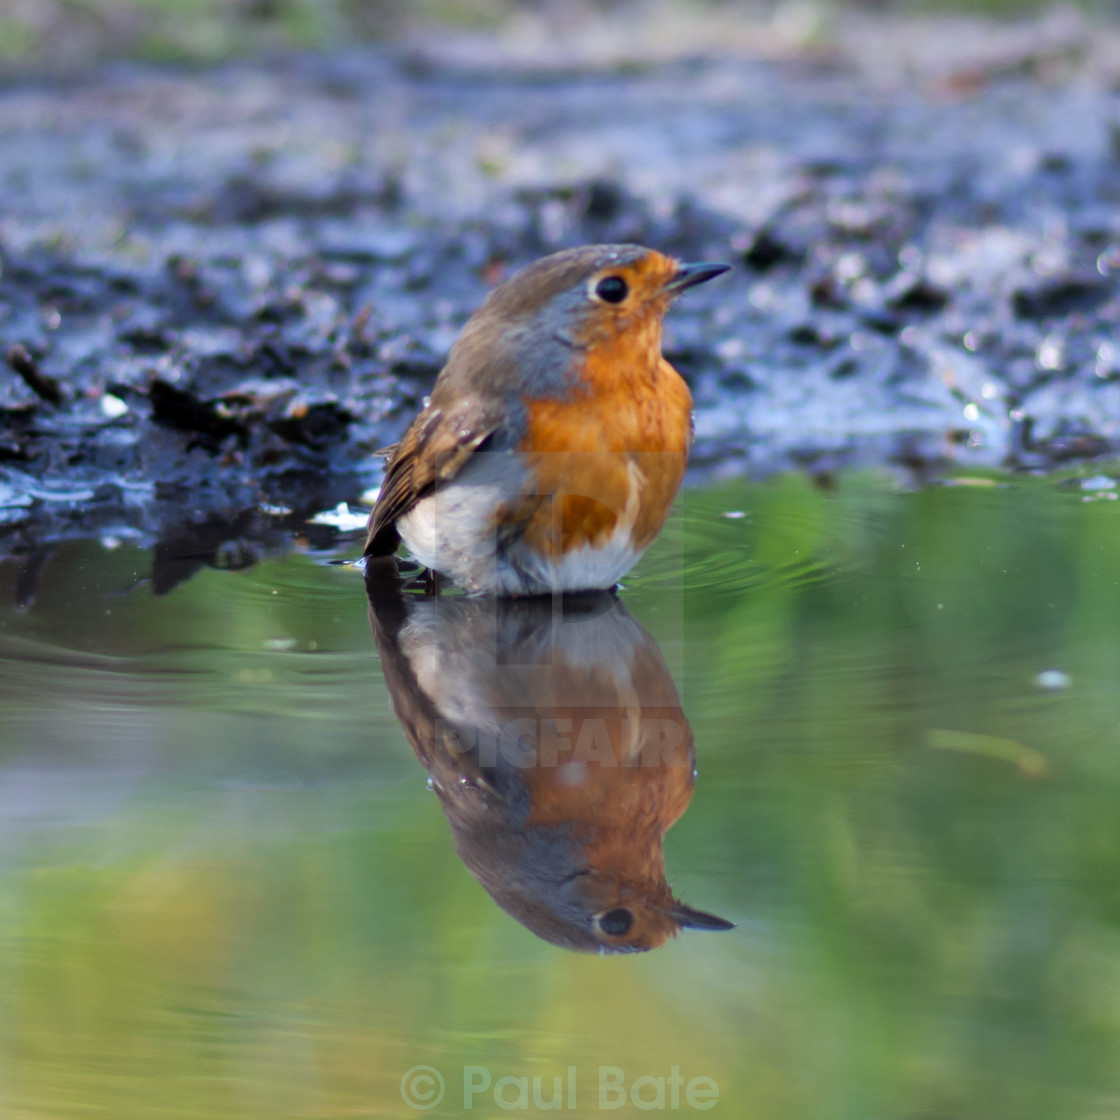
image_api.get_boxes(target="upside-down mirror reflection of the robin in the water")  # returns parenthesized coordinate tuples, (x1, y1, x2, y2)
(368, 582, 731, 952)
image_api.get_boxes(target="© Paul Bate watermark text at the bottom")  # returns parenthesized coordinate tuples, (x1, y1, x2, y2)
(401, 1065, 719, 1112)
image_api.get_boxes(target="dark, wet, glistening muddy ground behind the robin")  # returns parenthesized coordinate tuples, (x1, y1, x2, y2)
(0, 20, 1120, 563)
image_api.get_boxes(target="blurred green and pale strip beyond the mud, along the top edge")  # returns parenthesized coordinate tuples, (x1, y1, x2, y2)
(0, 0, 1116, 71)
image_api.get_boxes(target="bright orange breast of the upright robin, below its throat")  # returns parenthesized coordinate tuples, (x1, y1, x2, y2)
(510, 358, 692, 554)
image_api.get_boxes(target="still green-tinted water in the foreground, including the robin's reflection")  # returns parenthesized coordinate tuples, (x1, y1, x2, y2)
(0, 475, 1120, 1120)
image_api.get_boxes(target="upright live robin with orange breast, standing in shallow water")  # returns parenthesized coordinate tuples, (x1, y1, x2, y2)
(365, 245, 727, 595)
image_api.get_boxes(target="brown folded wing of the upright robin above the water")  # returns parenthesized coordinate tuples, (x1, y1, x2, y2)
(363, 402, 501, 557)
